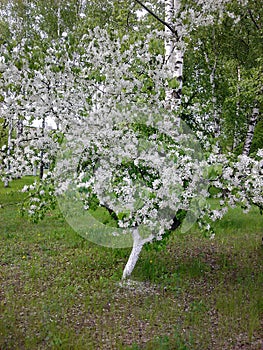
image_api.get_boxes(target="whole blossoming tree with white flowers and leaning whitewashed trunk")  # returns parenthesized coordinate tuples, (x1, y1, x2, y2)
(0, 1, 263, 278)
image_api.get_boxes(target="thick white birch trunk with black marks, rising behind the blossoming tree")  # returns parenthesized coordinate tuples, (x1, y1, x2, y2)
(165, 0, 184, 109)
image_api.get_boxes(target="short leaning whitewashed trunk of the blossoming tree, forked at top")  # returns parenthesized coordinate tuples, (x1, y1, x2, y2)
(122, 228, 154, 279)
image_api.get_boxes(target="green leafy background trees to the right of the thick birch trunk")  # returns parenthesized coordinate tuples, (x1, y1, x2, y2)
(184, 1, 262, 153)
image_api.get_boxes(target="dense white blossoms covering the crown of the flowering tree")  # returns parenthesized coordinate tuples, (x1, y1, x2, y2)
(1, 28, 262, 230)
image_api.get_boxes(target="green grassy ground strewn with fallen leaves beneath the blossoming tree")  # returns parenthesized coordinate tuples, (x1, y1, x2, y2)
(0, 178, 263, 350)
